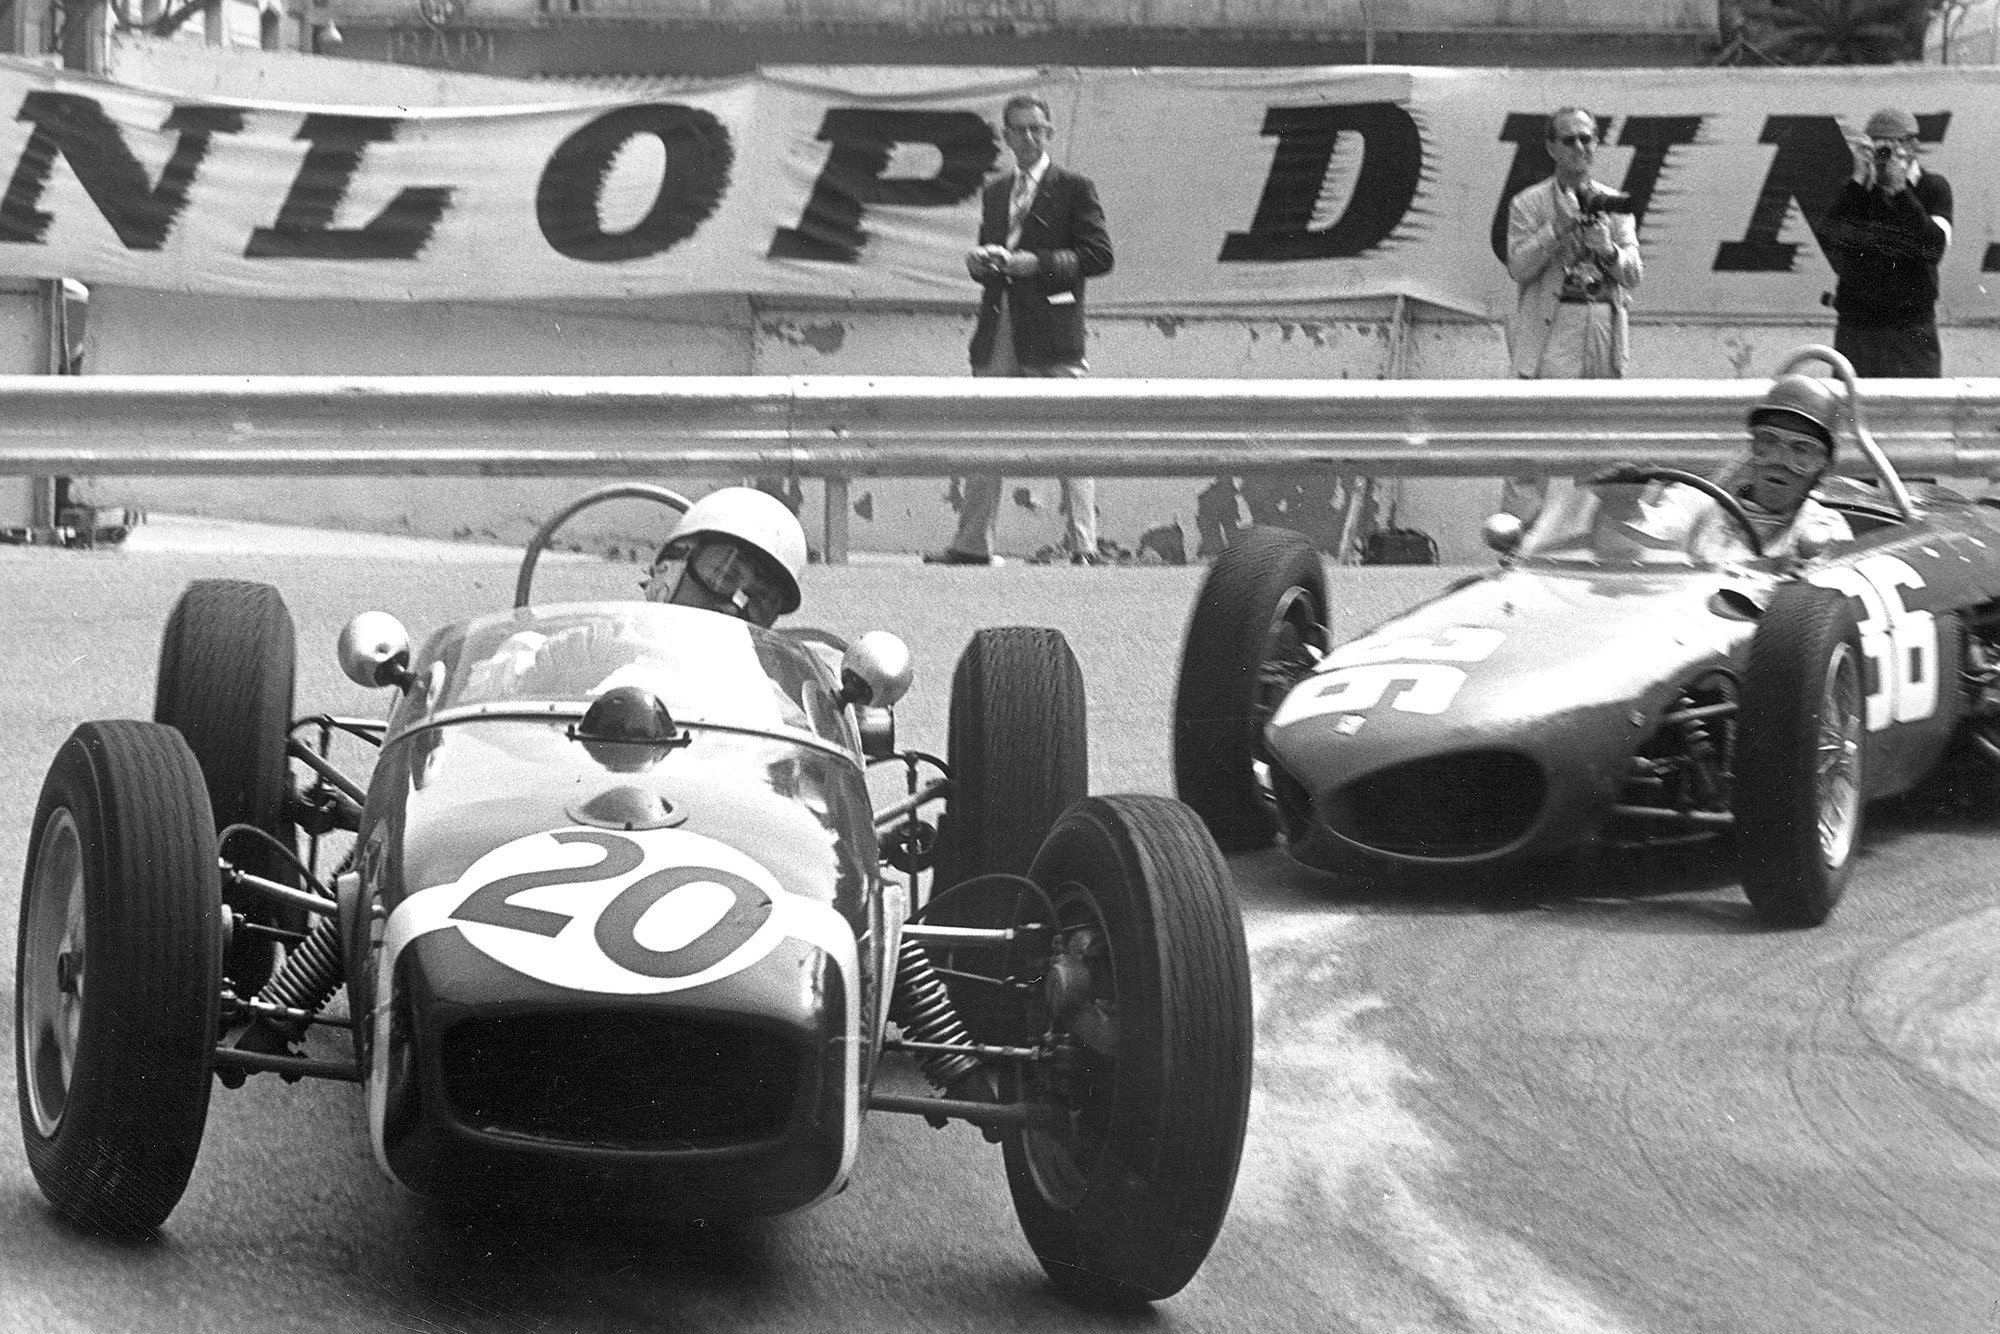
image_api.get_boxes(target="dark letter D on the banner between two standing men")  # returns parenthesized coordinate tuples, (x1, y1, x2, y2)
(1216, 102, 1424, 264)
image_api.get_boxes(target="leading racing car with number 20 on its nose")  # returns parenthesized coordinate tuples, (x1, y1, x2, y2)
(16, 486, 1252, 1300)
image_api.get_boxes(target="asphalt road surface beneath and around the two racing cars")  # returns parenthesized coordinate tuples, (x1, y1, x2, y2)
(0, 530, 2000, 1334)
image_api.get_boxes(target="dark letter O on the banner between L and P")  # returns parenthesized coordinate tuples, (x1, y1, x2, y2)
(534, 102, 736, 264)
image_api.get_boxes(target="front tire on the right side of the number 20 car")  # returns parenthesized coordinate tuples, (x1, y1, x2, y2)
(1002, 796, 1252, 1302)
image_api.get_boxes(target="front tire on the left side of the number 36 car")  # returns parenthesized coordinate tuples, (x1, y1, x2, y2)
(1174, 528, 1328, 852)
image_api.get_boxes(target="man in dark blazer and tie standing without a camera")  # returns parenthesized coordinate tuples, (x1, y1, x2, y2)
(924, 94, 1112, 566)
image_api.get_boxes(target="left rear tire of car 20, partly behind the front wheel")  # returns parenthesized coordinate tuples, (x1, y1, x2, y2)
(152, 580, 310, 996)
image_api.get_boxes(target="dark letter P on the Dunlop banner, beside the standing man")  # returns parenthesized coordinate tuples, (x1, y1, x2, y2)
(766, 106, 1000, 264)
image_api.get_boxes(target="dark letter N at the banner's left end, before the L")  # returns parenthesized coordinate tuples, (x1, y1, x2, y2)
(0, 88, 244, 250)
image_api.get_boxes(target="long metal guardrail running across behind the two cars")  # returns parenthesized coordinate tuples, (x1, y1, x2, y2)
(0, 376, 2000, 480)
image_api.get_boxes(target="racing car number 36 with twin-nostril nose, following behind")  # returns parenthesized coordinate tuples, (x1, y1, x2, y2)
(1174, 348, 2000, 926)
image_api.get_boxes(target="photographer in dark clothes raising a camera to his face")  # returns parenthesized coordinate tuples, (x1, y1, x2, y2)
(1820, 106, 1952, 378)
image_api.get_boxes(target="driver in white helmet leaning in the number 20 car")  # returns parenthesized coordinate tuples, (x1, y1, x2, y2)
(640, 486, 806, 628)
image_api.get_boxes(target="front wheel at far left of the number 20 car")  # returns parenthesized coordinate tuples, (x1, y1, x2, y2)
(14, 722, 222, 1236)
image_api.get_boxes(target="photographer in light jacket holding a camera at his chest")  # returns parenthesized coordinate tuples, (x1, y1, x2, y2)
(1500, 106, 1642, 520)
